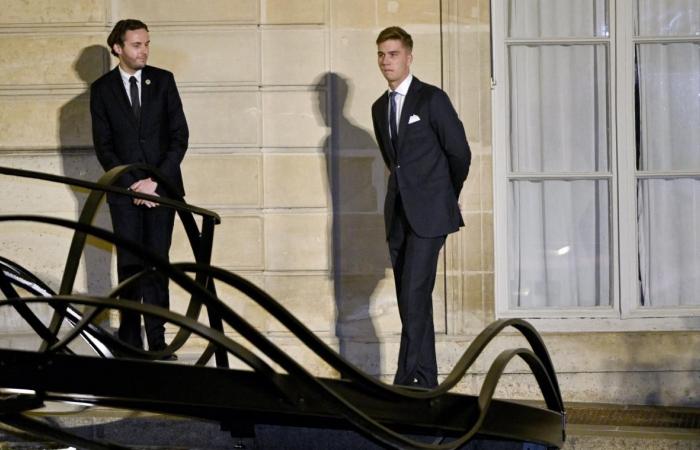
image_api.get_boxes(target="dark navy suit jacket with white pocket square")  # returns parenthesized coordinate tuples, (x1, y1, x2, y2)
(372, 77, 471, 237)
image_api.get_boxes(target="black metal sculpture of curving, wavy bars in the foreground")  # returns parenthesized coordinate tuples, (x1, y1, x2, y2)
(0, 165, 565, 449)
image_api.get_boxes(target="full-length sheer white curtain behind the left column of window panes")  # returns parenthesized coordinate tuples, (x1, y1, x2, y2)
(508, 0, 611, 308)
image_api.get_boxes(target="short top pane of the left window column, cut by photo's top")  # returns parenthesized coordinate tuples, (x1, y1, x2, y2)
(508, 0, 608, 38)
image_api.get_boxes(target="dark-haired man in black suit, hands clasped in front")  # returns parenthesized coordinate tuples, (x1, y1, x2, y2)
(90, 19, 189, 358)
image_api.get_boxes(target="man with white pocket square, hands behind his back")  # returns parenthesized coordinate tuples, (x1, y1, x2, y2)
(372, 27, 471, 388)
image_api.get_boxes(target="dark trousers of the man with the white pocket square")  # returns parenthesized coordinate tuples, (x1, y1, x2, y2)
(388, 197, 445, 388)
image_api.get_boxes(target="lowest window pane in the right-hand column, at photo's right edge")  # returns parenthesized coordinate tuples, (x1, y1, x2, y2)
(637, 178, 700, 307)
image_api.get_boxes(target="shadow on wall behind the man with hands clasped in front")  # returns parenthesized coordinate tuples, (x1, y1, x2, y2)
(58, 45, 112, 295)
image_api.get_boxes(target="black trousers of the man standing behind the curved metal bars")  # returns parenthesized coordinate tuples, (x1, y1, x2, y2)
(109, 203, 175, 350)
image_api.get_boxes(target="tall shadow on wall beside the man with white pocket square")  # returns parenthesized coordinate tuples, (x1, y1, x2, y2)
(315, 72, 395, 376)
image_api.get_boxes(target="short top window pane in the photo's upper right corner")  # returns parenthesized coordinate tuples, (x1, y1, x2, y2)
(635, 0, 700, 36)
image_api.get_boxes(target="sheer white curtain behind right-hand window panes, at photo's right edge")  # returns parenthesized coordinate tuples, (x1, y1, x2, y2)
(636, 0, 700, 307)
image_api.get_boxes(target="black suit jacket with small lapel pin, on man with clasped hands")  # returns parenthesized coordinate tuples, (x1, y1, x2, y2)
(90, 66, 189, 203)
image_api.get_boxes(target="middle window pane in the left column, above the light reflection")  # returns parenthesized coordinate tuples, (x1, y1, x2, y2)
(509, 45, 608, 172)
